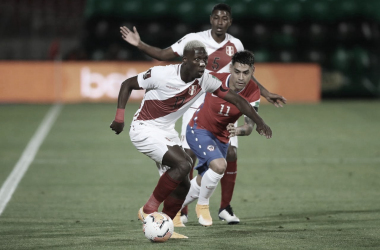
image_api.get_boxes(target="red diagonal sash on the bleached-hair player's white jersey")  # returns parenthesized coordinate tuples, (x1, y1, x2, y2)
(137, 80, 202, 121)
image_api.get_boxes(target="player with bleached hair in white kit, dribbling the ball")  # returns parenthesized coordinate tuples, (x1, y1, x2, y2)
(110, 40, 272, 238)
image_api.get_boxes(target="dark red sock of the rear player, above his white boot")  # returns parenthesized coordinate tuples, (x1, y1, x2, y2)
(220, 161, 237, 208)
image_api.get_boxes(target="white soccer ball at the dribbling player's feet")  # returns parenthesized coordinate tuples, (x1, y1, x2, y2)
(143, 212, 174, 242)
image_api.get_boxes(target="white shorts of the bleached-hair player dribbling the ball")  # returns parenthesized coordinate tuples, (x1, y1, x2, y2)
(129, 120, 181, 164)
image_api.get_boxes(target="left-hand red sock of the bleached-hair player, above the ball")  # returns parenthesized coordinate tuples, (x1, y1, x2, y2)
(143, 173, 180, 214)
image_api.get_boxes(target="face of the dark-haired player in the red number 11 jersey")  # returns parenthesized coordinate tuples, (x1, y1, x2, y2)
(230, 62, 255, 92)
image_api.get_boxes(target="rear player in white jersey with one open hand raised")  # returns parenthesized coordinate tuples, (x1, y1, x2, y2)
(120, 4, 286, 223)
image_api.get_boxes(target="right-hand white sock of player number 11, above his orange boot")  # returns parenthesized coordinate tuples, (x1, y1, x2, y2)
(198, 168, 224, 205)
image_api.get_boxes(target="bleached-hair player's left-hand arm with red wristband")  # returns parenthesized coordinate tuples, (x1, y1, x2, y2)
(110, 76, 141, 135)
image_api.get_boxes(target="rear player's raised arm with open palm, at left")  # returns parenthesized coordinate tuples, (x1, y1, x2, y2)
(120, 26, 177, 61)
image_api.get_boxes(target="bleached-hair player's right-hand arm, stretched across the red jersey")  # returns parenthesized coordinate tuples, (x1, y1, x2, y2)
(214, 88, 272, 139)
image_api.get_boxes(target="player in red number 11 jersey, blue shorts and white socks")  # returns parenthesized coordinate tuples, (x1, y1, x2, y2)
(184, 51, 260, 226)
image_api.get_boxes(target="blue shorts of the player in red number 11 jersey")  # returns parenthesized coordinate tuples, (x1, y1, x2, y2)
(186, 125, 228, 176)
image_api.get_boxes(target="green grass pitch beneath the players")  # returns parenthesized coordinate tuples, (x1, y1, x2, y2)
(0, 101, 380, 250)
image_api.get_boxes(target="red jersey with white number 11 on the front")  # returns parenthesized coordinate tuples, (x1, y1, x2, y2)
(189, 73, 260, 143)
